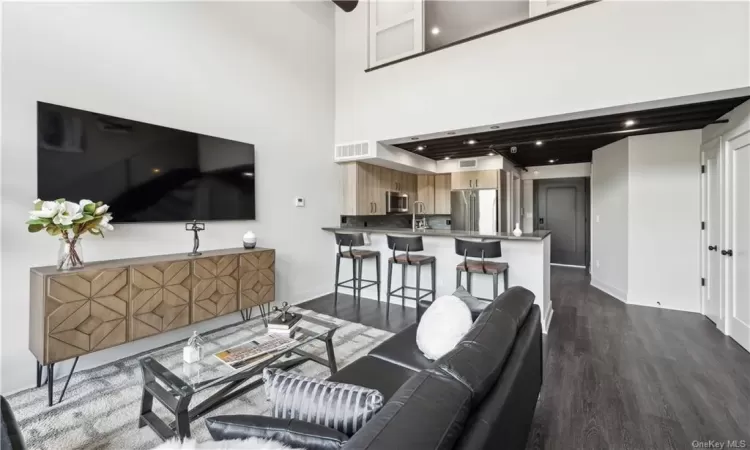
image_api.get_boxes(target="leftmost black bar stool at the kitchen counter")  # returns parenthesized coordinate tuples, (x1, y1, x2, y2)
(333, 233, 380, 307)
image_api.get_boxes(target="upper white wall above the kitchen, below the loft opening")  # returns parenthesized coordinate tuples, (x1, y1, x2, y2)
(335, 0, 750, 142)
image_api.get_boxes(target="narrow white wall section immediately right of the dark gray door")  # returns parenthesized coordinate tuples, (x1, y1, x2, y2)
(591, 139, 628, 301)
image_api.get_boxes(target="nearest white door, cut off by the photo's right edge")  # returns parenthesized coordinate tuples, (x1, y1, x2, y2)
(724, 130, 750, 351)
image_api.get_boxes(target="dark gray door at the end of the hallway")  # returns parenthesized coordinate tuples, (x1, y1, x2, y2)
(534, 178, 588, 267)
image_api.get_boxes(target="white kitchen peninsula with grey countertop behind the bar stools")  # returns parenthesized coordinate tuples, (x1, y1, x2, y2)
(323, 227, 552, 332)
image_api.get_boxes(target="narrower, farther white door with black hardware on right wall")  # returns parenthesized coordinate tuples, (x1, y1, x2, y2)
(701, 139, 724, 329)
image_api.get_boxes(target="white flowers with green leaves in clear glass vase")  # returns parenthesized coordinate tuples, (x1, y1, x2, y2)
(26, 198, 115, 268)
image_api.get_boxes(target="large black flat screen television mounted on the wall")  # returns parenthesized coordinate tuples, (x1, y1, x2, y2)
(37, 102, 255, 222)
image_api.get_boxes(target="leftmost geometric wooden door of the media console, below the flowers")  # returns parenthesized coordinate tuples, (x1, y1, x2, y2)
(45, 268, 128, 362)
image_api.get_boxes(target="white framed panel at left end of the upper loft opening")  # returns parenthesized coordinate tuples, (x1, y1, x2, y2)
(368, 0, 424, 67)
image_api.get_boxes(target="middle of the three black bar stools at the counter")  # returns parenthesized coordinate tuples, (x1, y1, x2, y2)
(385, 235, 435, 322)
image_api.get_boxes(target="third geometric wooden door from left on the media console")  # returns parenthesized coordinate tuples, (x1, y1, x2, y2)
(191, 255, 239, 323)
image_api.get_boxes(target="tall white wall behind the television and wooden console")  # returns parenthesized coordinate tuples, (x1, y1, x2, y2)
(0, 1, 334, 393)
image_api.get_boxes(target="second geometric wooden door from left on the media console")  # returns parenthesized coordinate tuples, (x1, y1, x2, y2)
(130, 261, 191, 339)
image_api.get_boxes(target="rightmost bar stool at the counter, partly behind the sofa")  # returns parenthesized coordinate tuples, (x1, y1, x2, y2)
(456, 239, 508, 300)
